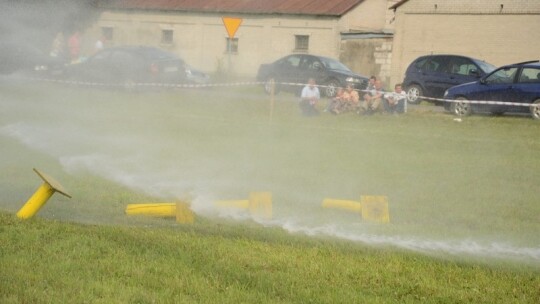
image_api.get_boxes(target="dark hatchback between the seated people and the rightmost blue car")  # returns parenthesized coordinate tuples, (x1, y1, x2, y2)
(403, 55, 496, 104)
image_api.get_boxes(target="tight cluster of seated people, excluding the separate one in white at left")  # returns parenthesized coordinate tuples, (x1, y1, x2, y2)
(326, 76, 407, 115)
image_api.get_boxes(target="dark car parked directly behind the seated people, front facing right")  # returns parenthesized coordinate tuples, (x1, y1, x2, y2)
(257, 54, 368, 97)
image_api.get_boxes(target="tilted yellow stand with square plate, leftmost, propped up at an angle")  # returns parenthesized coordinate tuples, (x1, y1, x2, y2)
(17, 168, 71, 219)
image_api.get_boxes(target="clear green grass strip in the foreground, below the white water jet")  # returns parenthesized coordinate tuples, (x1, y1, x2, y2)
(0, 213, 540, 303)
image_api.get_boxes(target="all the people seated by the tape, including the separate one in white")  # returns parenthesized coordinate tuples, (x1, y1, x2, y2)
(300, 76, 407, 116)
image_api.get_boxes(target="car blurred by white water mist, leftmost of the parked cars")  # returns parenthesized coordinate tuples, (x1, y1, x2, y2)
(65, 46, 209, 87)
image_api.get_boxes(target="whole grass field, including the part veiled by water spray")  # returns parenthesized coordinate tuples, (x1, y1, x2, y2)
(0, 83, 540, 303)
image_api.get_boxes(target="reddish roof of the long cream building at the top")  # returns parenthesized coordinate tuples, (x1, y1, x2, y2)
(98, 0, 364, 16)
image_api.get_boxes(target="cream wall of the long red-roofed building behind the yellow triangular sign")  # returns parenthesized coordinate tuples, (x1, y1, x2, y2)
(85, 12, 340, 76)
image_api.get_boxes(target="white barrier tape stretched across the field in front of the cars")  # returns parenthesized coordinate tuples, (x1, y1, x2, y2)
(23, 78, 540, 107)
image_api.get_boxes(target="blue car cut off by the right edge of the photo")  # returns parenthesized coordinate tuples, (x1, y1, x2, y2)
(444, 61, 540, 119)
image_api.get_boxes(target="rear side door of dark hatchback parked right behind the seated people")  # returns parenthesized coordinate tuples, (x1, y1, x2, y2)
(420, 56, 449, 97)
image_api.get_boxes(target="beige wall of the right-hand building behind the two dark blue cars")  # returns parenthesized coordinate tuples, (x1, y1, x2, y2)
(391, 0, 540, 84)
